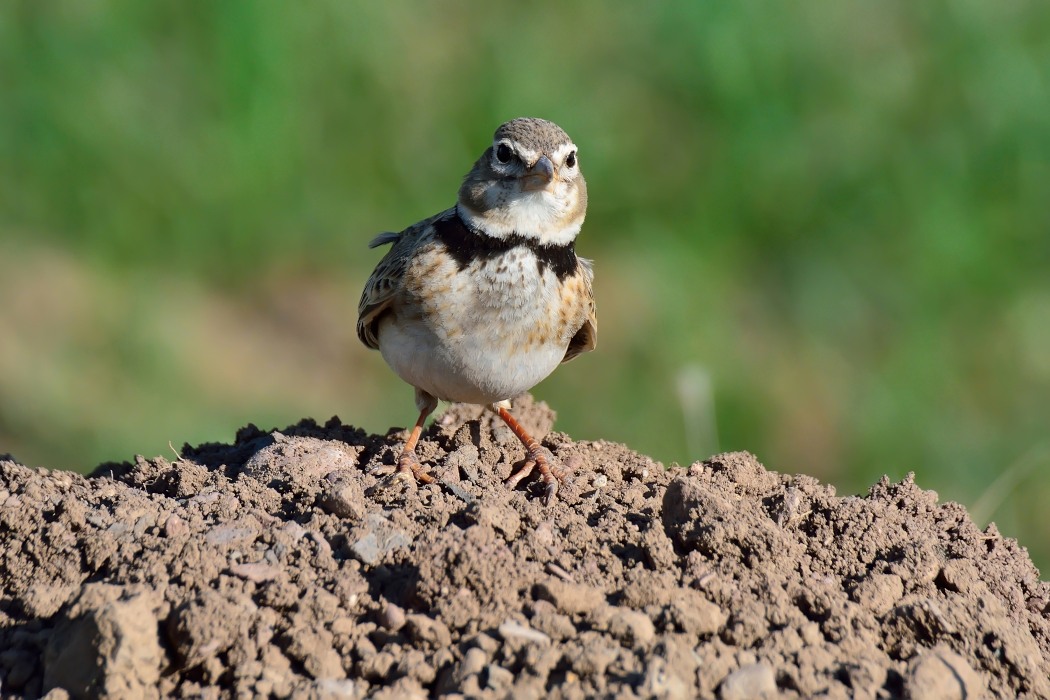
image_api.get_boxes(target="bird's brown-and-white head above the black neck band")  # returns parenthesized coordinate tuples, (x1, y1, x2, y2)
(458, 118, 587, 246)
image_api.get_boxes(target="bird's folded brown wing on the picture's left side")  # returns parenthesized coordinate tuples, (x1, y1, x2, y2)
(357, 212, 447, 349)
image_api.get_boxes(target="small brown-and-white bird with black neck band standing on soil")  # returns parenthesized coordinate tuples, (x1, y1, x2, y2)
(357, 118, 597, 505)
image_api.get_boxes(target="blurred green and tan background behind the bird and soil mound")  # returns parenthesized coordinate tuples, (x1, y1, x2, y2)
(0, 0, 1050, 568)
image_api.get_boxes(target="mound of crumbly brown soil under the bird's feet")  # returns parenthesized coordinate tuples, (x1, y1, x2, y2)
(0, 397, 1050, 700)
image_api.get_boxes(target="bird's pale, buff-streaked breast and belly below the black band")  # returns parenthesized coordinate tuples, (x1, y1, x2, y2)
(380, 242, 589, 403)
